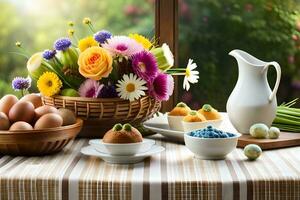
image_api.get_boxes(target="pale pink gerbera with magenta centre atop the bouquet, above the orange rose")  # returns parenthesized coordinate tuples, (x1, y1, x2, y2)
(101, 36, 144, 57)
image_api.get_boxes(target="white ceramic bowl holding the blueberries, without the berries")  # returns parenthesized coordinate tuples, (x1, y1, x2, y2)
(184, 133, 241, 160)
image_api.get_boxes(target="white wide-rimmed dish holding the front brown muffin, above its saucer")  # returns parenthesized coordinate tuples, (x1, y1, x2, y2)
(89, 139, 155, 156)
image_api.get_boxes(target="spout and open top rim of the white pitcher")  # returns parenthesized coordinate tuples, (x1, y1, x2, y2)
(229, 49, 266, 67)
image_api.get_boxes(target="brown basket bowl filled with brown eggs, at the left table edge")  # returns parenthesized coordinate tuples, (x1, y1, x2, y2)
(0, 94, 83, 156)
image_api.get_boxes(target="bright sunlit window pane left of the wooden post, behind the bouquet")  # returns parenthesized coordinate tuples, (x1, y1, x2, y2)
(0, 0, 154, 96)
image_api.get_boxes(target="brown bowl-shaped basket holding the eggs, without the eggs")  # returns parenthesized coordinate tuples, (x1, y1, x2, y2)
(0, 119, 83, 156)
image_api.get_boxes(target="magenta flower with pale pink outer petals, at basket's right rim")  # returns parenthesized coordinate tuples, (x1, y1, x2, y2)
(148, 73, 174, 101)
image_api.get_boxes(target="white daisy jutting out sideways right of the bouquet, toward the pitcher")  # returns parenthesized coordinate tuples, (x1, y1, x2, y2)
(183, 59, 199, 91)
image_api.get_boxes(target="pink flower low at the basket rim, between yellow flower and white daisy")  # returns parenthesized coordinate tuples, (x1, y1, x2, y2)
(78, 79, 103, 98)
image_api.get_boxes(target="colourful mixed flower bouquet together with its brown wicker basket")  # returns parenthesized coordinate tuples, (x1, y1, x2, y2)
(16, 18, 198, 137)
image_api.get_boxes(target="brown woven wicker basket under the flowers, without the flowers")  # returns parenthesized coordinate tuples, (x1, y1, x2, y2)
(42, 96, 161, 138)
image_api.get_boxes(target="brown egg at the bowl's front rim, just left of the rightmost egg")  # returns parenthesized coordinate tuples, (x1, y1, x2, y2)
(34, 113, 63, 129)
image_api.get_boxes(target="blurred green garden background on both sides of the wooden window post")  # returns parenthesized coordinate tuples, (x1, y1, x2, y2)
(0, 0, 300, 110)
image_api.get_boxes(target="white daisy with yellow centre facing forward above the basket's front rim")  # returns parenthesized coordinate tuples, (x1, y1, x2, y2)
(116, 73, 147, 101)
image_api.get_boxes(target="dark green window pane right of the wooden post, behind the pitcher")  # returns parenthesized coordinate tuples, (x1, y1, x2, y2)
(179, 0, 300, 111)
